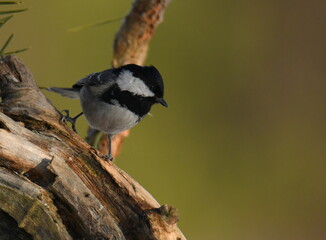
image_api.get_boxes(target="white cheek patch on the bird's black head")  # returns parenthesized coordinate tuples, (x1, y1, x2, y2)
(117, 70, 154, 97)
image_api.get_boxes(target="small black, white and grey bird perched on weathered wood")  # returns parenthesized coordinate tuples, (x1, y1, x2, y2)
(47, 64, 168, 160)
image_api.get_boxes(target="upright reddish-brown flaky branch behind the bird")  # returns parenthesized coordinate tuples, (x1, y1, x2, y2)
(87, 0, 170, 157)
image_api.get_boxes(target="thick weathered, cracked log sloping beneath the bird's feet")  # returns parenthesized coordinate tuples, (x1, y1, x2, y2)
(0, 56, 185, 240)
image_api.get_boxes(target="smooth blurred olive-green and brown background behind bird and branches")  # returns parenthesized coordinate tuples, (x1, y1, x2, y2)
(0, 0, 326, 240)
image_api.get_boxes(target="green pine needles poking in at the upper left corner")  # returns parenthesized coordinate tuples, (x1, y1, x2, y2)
(0, 1, 28, 56)
